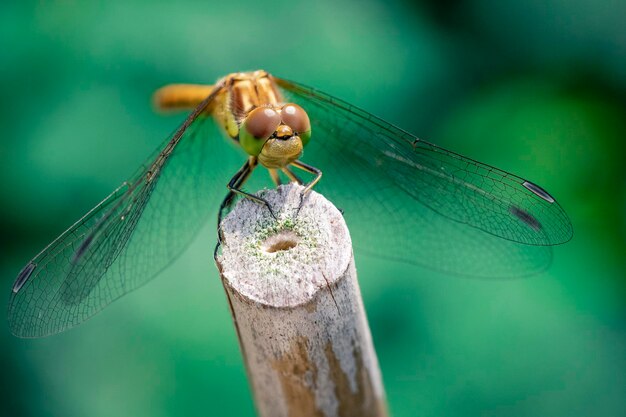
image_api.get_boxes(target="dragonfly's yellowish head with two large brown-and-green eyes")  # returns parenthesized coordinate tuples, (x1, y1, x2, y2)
(239, 103, 311, 168)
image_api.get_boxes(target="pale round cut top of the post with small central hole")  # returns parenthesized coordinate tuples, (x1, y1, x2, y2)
(219, 184, 352, 307)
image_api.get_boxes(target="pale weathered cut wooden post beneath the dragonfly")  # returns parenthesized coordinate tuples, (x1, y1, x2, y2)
(218, 184, 387, 417)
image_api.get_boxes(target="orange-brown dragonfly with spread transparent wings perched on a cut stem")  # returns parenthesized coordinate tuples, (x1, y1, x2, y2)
(8, 70, 572, 337)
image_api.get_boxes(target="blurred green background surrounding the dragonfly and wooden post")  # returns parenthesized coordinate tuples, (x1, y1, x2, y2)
(0, 0, 626, 417)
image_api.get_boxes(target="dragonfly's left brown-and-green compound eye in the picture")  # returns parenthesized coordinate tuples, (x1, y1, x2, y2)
(239, 107, 280, 155)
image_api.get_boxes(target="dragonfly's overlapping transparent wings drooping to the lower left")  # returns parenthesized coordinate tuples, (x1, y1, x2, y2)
(8, 89, 241, 337)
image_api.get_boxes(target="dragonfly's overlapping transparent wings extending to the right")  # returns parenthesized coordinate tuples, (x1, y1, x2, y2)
(276, 79, 572, 277)
